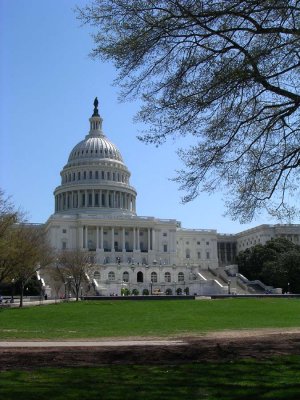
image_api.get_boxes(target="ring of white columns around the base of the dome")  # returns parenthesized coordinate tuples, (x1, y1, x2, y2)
(55, 189, 136, 212)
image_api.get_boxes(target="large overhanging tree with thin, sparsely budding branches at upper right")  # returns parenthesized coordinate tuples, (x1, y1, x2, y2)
(78, 0, 300, 222)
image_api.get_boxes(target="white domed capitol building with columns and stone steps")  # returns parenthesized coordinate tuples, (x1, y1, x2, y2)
(46, 98, 300, 295)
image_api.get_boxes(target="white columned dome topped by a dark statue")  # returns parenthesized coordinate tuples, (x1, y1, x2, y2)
(54, 98, 136, 215)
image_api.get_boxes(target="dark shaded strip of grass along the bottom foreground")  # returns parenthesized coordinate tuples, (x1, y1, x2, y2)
(0, 356, 300, 400)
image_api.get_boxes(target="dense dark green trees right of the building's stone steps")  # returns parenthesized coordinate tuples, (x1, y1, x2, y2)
(237, 238, 300, 293)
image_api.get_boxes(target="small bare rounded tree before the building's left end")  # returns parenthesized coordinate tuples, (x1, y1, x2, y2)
(56, 249, 92, 301)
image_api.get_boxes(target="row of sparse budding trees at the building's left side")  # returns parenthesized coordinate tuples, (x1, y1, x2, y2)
(0, 190, 92, 307)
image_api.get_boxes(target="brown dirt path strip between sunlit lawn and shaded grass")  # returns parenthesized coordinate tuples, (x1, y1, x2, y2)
(0, 329, 300, 370)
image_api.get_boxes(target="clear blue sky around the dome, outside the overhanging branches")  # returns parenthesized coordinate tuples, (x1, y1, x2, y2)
(0, 0, 297, 233)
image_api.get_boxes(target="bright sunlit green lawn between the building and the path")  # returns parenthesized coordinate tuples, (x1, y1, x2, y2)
(0, 298, 300, 340)
